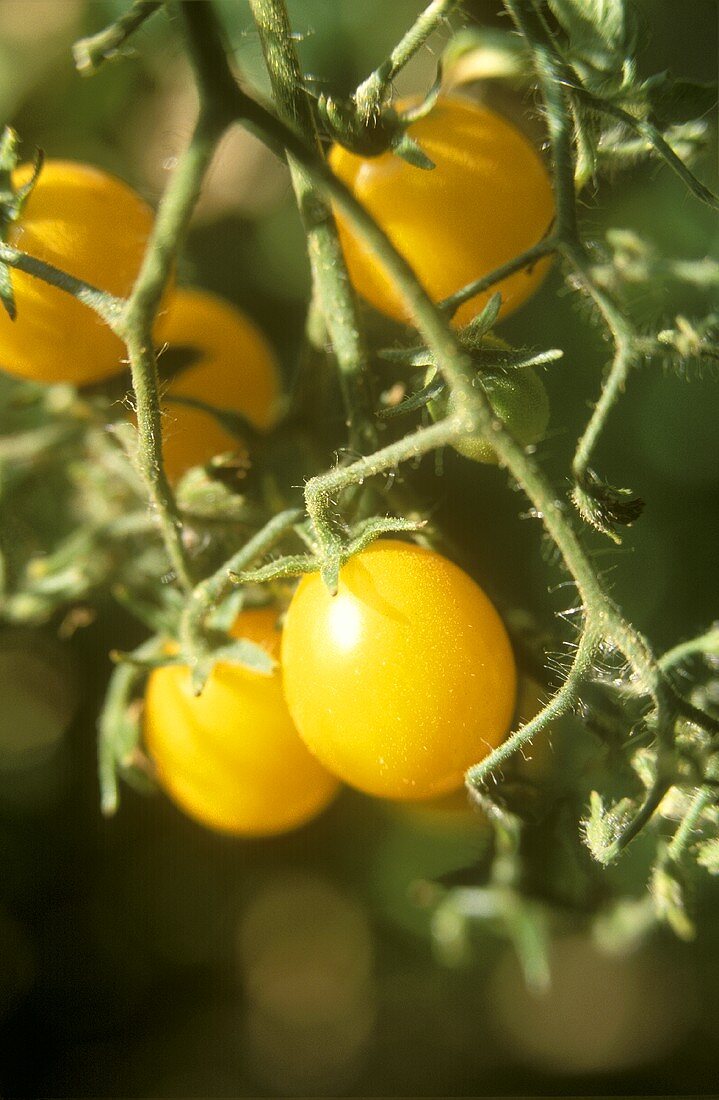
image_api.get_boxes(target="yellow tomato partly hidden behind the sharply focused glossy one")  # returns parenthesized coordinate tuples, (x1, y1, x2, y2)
(144, 609, 338, 836)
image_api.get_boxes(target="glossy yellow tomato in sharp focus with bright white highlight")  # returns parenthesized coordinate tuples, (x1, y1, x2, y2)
(283, 539, 517, 800)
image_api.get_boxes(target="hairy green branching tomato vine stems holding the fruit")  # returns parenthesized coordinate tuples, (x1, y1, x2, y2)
(0, 0, 719, 963)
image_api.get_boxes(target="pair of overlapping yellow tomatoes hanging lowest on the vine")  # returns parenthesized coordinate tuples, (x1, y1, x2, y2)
(145, 539, 517, 835)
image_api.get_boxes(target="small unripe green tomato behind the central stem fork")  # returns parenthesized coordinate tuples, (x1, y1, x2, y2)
(424, 366, 550, 464)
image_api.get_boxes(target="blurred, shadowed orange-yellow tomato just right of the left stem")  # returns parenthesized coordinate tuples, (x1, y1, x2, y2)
(155, 289, 280, 480)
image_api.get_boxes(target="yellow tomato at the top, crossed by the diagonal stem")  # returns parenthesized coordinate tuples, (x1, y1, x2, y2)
(330, 97, 554, 325)
